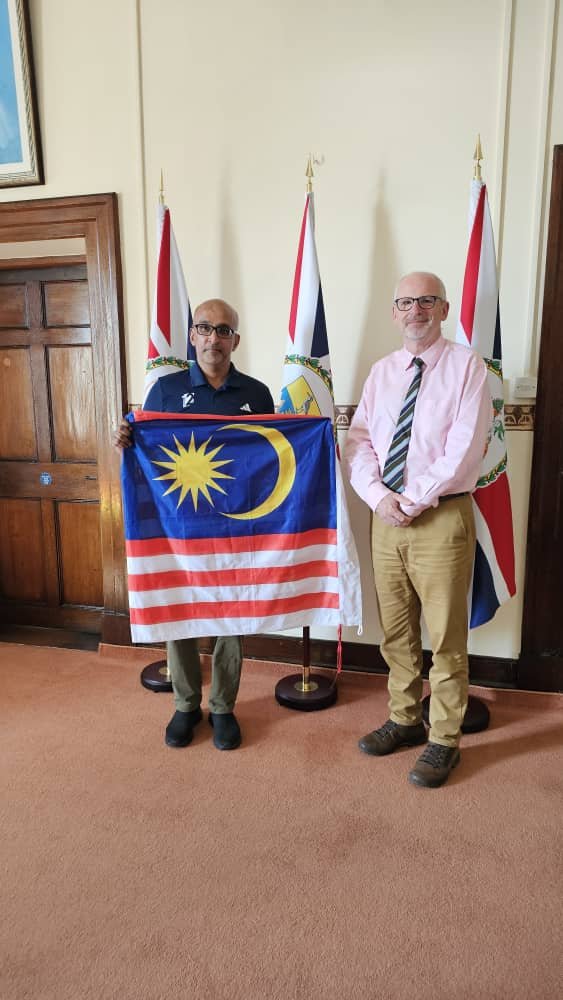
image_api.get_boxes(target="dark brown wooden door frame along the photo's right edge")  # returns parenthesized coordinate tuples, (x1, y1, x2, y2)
(518, 146, 563, 691)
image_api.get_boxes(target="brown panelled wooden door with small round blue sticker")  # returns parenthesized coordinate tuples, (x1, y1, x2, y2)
(0, 264, 104, 632)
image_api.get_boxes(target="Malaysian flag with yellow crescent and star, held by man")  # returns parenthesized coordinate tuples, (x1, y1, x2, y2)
(122, 412, 361, 642)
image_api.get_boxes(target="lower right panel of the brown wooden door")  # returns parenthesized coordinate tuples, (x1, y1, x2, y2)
(57, 503, 104, 607)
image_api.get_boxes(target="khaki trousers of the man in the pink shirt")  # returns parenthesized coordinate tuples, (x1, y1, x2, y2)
(372, 496, 475, 747)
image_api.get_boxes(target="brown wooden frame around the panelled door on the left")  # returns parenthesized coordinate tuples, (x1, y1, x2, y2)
(0, 194, 131, 643)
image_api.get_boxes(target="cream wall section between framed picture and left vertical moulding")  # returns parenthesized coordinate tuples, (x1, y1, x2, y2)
(0, 0, 148, 384)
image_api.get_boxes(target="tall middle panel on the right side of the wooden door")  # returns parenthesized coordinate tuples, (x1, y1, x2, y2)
(48, 347, 97, 462)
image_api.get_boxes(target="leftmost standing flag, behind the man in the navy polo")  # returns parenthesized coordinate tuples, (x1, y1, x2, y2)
(143, 203, 193, 400)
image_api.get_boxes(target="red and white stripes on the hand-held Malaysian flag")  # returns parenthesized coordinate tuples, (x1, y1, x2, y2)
(127, 529, 341, 642)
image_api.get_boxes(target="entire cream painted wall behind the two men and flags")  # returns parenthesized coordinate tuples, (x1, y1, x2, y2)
(0, 0, 563, 657)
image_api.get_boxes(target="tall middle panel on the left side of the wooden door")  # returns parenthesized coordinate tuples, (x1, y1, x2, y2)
(0, 347, 37, 461)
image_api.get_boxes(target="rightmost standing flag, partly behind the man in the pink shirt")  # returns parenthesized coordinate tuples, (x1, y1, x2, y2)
(456, 180, 516, 628)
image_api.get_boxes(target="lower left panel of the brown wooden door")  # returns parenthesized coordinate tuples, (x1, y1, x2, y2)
(0, 498, 47, 602)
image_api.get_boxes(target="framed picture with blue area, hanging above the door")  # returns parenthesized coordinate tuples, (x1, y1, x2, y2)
(0, 0, 43, 187)
